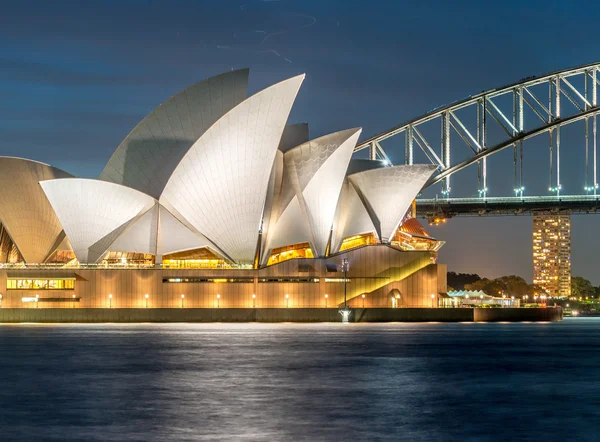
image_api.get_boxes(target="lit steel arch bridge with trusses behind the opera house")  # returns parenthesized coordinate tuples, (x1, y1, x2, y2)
(355, 63, 600, 218)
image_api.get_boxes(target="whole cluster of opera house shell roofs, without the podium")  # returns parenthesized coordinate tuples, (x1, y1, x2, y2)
(7, 69, 435, 264)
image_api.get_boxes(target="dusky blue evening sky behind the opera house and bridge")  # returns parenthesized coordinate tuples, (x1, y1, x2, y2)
(0, 0, 600, 285)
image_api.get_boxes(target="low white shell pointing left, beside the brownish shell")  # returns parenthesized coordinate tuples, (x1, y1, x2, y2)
(40, 178, 156, 262)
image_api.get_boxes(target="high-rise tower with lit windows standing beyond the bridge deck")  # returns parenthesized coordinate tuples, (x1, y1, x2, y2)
(533, 213, 571, 297)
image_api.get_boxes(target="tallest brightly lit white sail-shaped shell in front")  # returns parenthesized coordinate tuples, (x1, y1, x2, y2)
(160, 75, 304, 263)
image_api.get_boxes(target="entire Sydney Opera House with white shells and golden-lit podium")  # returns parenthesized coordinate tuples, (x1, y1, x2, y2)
(0, 69, 446, 308)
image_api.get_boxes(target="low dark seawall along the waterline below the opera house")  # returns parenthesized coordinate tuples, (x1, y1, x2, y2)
(0, 307, 563, 323)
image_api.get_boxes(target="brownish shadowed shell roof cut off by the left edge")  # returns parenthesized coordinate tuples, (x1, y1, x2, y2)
(0, 157, 71, 264)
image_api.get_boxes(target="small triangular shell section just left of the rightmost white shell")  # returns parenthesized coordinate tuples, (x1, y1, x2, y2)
(331, 179, 376, 253)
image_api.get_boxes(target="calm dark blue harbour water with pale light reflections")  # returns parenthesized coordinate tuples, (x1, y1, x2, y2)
(0, 318, 600, 441)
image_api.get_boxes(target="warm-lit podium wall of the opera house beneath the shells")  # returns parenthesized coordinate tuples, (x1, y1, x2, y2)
(0, 245, 436, 309)
